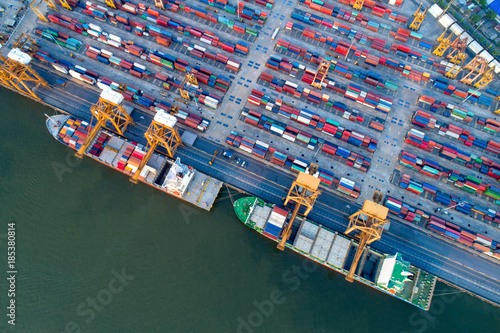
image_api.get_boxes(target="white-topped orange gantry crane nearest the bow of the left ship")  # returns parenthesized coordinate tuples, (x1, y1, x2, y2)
(75, 89, 133, 158)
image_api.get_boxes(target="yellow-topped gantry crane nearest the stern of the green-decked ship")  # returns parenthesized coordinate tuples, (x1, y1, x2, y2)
(345, 191, 389, 282)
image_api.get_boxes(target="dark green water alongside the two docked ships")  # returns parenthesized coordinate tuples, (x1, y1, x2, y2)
(0, 90, 500, 333)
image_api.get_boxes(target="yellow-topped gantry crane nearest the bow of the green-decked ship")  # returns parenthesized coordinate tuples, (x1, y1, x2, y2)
(278, 172, 321, 251)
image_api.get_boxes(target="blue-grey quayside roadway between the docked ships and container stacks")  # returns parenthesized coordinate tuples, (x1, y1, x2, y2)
(26, 65, 500, 304)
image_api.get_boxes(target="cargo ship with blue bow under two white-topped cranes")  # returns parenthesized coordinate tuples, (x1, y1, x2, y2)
(46, 115, 222, 211)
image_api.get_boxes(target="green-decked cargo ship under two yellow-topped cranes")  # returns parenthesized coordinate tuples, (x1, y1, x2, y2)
(234, 197, 437, 310)
